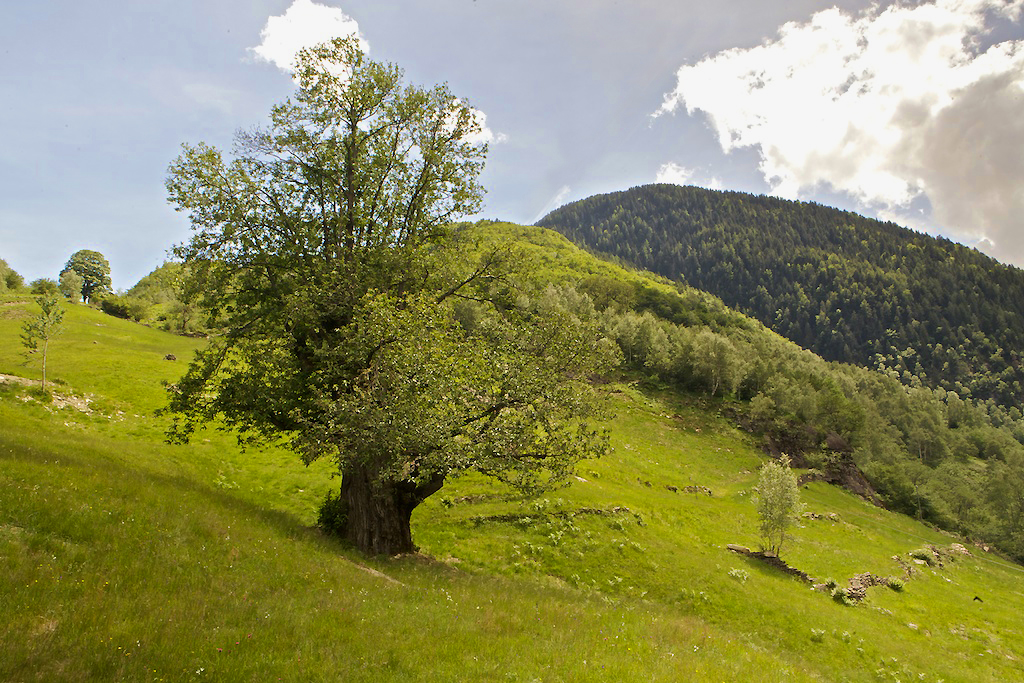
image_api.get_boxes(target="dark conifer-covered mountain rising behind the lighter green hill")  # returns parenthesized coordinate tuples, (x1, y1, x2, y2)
(539, 184, 1024, 404)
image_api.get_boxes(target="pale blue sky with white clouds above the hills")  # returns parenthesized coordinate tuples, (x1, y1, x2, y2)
(0, 0, 1024, 289)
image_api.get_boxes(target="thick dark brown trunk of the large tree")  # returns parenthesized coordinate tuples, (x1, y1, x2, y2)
(341, 465, 444, 555)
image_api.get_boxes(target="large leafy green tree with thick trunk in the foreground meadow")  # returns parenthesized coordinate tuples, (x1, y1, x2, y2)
(167, 40, 606, 554)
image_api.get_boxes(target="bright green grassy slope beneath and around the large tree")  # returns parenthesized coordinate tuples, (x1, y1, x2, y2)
(0, 260, 1024, 681)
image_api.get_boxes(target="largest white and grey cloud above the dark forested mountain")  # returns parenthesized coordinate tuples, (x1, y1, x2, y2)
(654, 0, 1024, 265)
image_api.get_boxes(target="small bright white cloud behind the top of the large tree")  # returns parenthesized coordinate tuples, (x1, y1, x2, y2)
(249, 0, 370, 72)
